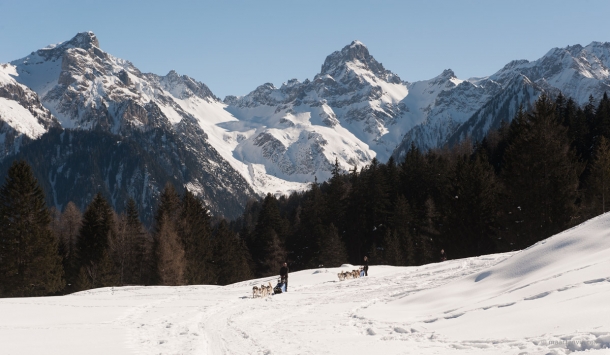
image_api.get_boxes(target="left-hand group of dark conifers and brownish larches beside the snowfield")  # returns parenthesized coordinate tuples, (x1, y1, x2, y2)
(0, 165, 252, 297)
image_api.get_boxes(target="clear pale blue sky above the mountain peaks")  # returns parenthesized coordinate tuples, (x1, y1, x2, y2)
(0, 0, 610, 98)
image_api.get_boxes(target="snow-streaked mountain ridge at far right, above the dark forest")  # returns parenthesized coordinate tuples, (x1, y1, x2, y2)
(404, 42, 610, 156)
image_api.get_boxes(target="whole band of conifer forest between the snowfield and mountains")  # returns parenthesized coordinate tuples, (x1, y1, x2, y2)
(0, 94, 610, 297)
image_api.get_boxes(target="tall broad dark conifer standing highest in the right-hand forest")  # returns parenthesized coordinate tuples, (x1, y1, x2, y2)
(503, 95, 582, 248)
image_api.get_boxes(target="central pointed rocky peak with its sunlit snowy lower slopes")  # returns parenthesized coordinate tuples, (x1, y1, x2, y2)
(224, 41, 408, 182)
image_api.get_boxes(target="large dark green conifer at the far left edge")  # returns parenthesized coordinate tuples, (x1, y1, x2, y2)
(0, 161, 65, 297)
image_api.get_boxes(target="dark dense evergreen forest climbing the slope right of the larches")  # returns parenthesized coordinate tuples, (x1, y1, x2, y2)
(232, 94, 610, 276)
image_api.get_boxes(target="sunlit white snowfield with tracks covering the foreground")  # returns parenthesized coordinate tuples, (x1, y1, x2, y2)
(0, 214, 610, 355)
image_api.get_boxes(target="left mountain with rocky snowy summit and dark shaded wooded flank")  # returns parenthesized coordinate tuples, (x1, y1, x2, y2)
(0, 32, 255, 220)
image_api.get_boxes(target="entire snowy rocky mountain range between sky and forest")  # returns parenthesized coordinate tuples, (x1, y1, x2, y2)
(0, 32, 610, 220)
